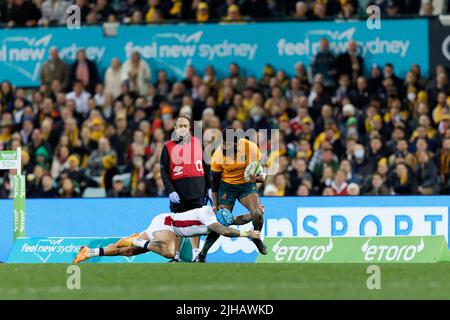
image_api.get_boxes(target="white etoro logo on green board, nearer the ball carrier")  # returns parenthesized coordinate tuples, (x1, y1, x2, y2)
(272, 238, 333, 262)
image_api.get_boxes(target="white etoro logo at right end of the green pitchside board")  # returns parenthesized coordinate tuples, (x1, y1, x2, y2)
(361, 238, 425, 261)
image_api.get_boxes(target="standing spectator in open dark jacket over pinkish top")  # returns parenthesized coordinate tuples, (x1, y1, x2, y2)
(69, 49, 99, 94)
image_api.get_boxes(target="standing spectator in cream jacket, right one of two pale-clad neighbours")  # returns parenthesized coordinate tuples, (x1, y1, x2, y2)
(121, 51, 151, 95)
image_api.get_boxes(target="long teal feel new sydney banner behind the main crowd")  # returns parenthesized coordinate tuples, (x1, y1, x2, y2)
(0, 19, 429, 86)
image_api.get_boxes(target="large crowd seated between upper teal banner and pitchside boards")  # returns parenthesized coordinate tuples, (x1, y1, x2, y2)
(0, 38, 450, 197)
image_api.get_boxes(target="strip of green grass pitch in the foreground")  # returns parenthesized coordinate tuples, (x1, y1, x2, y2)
(0, 263, 450, 300)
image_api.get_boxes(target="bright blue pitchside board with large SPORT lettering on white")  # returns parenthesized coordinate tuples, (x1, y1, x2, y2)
(0, 196, 450, 262)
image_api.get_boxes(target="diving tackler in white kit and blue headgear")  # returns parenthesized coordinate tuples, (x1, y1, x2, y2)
(73, 206, 260, 264)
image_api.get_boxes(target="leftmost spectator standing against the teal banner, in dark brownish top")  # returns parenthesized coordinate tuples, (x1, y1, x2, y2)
(40, 47, 69, 88)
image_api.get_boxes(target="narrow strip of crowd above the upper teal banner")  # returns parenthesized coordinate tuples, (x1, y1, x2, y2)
(0, 0, 450, 27)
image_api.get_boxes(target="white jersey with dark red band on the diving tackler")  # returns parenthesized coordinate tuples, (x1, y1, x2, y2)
(164, 206, 217, 237)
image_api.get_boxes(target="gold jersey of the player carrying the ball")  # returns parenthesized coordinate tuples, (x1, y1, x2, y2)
(211, 139, 261, 184)
